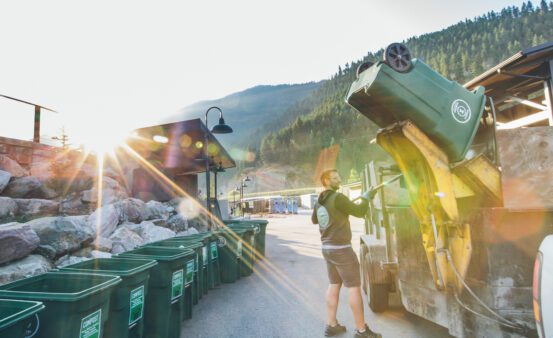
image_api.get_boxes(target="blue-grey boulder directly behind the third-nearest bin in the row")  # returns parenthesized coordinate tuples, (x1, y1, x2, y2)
(25, 215, 95, 257)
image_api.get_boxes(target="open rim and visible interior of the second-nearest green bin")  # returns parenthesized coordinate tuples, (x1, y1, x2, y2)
(0, 272, 121, 302)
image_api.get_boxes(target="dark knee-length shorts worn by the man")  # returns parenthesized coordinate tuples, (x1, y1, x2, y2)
(323, 247, 361, 288)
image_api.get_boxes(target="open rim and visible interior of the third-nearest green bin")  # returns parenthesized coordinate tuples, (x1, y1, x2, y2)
(61, 258, 157, 277)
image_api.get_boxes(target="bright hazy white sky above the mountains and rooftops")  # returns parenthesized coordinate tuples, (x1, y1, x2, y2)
(0, 0, 524, 147)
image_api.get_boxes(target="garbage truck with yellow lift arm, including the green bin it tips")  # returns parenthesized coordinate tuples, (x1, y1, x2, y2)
(346, 43, 553, 338)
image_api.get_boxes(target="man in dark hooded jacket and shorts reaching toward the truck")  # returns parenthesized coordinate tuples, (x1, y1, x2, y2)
(311, 169, 381, 338)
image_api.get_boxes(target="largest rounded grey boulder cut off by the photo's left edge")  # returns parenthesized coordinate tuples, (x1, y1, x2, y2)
(0, 223, 40, 264)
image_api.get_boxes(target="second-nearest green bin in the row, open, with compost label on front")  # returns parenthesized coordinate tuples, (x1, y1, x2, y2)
(0, 272, 121, 338)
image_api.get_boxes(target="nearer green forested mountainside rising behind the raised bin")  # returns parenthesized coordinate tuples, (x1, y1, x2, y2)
(259, 1, 553, 182)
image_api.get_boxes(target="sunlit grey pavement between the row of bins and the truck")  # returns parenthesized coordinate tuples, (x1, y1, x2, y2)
(181, 213, 450, 338)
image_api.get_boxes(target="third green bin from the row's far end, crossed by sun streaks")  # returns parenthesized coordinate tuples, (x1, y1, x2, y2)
(219, 228, 246, 283)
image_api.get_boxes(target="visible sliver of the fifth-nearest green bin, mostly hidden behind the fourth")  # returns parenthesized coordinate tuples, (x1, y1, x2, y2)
(140, 241, 196, 320)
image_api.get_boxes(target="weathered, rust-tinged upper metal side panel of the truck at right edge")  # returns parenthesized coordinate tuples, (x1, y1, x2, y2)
(497, 127, 553, 209)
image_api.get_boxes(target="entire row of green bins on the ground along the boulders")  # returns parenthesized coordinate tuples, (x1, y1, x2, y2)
(0, 220, 267, 338)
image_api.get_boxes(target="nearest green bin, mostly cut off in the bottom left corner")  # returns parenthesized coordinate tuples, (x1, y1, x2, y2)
(0, 299, 44, 338)
